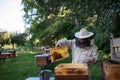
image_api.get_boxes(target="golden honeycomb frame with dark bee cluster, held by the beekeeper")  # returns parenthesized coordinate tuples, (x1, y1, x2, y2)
(50, 46, 69, 62)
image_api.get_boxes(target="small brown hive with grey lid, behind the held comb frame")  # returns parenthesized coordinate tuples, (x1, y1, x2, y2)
(35, 54, 51, 66)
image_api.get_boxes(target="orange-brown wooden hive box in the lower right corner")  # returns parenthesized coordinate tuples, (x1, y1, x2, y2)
(102, 61, 120, 80)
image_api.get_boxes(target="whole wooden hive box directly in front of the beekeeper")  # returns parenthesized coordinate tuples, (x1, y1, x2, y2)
(55, 63, 89, 80)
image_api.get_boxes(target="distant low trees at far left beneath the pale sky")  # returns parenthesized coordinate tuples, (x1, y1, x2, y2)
(0, 31, 28, 48)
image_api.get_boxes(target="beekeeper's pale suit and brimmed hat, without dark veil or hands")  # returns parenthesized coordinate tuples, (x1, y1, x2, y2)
(56, 30, 98, 63)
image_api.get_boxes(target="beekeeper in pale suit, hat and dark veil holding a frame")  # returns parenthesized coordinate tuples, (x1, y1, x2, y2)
(56, 28, 98, 63)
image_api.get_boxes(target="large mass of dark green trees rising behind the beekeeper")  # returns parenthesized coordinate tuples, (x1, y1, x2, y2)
(22, 0, 120, 52)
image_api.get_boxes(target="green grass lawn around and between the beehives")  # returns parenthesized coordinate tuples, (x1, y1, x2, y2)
(0, 52, 102, 80)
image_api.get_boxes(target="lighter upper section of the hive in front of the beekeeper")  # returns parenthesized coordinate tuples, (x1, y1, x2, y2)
(55, 63, 88, 76)
